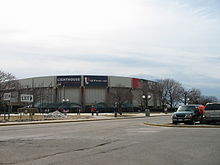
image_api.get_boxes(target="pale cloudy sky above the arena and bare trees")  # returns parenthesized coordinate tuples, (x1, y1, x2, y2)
(0, 0, 220, 99)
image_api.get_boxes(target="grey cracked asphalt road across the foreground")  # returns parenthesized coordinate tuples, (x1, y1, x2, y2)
(0, 117, 220, 165)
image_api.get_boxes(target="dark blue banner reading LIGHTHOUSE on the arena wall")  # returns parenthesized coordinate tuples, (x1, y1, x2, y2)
(57, 76, 81, 87)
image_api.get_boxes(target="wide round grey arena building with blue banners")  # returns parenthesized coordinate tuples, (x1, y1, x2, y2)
(1, 75, 160, 111)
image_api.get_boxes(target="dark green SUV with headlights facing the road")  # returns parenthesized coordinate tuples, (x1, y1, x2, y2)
(172, 104, 201, 124)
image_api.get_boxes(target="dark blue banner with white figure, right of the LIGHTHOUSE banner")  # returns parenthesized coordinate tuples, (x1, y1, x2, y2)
(84, 76, 108, 87)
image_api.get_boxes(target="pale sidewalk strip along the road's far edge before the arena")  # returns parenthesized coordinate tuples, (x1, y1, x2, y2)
(0, 113, 171, 126)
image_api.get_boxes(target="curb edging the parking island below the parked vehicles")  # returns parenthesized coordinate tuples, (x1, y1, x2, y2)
(144, 123, 220, 128)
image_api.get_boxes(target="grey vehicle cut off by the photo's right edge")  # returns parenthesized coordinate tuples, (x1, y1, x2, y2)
(204, 103, 220, 124)
